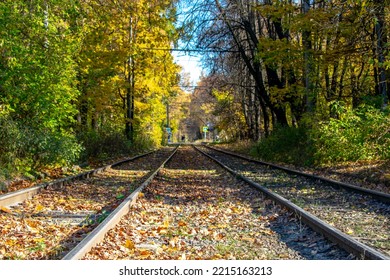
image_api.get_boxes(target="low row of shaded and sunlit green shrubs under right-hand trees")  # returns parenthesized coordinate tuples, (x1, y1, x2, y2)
(252, 105, 390, 165)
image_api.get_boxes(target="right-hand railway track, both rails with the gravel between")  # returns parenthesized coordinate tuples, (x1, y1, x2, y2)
(197, 146, 390, 259)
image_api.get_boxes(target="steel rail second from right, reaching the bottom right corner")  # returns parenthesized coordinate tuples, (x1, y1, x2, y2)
(194, 146, 390, 260)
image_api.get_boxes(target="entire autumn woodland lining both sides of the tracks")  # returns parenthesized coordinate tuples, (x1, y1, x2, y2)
(0, 0, 390, 178)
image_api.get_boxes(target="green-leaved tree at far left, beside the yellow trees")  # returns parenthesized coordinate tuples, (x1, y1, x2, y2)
(0, 1, 78, 131)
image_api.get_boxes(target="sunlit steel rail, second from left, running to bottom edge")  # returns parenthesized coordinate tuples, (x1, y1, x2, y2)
(62, 145, 179, 260)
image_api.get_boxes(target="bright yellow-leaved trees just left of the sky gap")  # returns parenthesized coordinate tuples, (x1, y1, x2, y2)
(76, 1, 180, 147)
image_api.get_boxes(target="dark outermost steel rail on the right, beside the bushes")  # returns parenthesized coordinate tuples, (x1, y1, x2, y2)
(203, 145, 390, 204)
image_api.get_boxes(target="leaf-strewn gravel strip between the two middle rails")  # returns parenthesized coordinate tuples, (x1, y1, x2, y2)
(84, 146, 354, 260)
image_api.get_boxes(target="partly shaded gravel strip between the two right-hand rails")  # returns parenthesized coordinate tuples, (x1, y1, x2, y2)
(202, 148, 390, 255)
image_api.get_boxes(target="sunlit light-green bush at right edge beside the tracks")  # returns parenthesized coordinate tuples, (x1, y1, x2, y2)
(313, 106, 390, 163)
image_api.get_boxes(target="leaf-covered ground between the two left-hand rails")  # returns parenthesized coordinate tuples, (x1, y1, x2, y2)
(0, 148, 173, 259)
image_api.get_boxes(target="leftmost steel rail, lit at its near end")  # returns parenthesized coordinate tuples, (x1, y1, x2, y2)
(0, 151, 155, 207)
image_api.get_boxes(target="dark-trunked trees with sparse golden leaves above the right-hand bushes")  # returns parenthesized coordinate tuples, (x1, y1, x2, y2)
(184, 0, 388, 143)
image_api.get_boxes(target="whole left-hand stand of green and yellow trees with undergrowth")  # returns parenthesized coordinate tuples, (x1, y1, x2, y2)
(0, 0, 181, 178)
